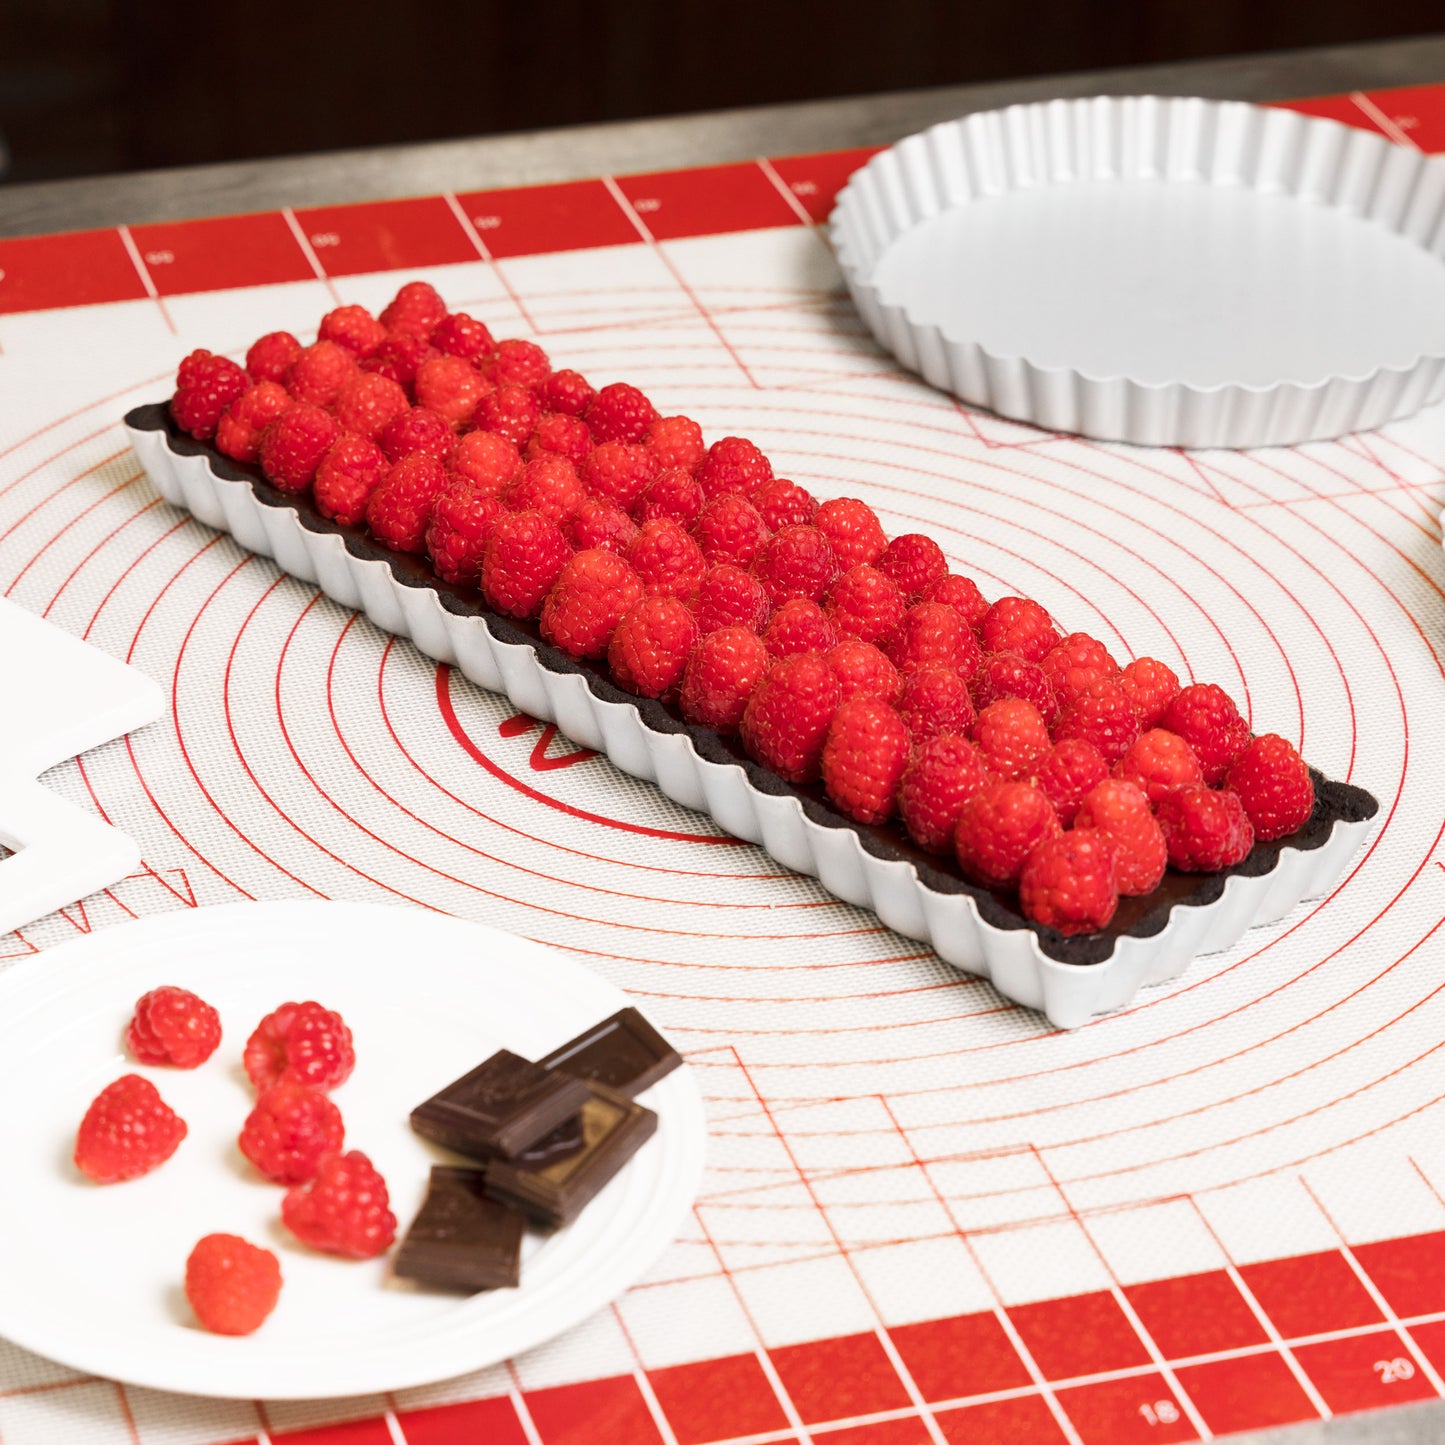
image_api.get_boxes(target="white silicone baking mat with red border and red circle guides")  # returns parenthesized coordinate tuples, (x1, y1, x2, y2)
(8, 87, 1445, 1445)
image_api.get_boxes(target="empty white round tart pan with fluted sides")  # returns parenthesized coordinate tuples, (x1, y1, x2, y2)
(831, 95, 1445, 447)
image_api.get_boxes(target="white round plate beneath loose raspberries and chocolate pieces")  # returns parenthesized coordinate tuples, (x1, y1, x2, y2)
(0, 903, 705, 1399)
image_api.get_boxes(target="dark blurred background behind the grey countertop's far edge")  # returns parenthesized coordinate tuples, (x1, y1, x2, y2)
(0, 0, 1445, 181)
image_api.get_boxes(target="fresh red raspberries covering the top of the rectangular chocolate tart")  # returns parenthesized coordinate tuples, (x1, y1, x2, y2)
(171, 282, 1314, 933)
